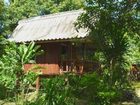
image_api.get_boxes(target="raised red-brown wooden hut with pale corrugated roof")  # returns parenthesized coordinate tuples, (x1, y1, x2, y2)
(10, 10, 97, 88)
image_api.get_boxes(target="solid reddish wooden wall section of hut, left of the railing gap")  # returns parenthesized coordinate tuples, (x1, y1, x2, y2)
(25, 42, 69, 74)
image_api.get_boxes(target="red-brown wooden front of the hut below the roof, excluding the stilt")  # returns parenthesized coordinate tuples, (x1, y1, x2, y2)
(25, 42, 98, 75)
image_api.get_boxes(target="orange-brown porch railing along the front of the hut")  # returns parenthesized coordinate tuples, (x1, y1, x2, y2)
(24, 60, 99, 75)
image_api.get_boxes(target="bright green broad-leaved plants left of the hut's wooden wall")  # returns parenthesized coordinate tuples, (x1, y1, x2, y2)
(0, 42, 40, 101)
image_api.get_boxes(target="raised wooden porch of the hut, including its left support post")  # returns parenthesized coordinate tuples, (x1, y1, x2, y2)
(24, 41, 99, 89)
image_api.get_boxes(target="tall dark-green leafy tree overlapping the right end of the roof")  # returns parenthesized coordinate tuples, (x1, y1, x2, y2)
(77, 0, 140, 83)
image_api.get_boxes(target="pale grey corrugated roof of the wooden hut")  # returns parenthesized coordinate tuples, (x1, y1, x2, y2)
(10, 10, 86, 42)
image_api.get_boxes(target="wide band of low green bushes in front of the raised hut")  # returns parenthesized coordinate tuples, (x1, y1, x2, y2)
(29, 73, 131, 105)
